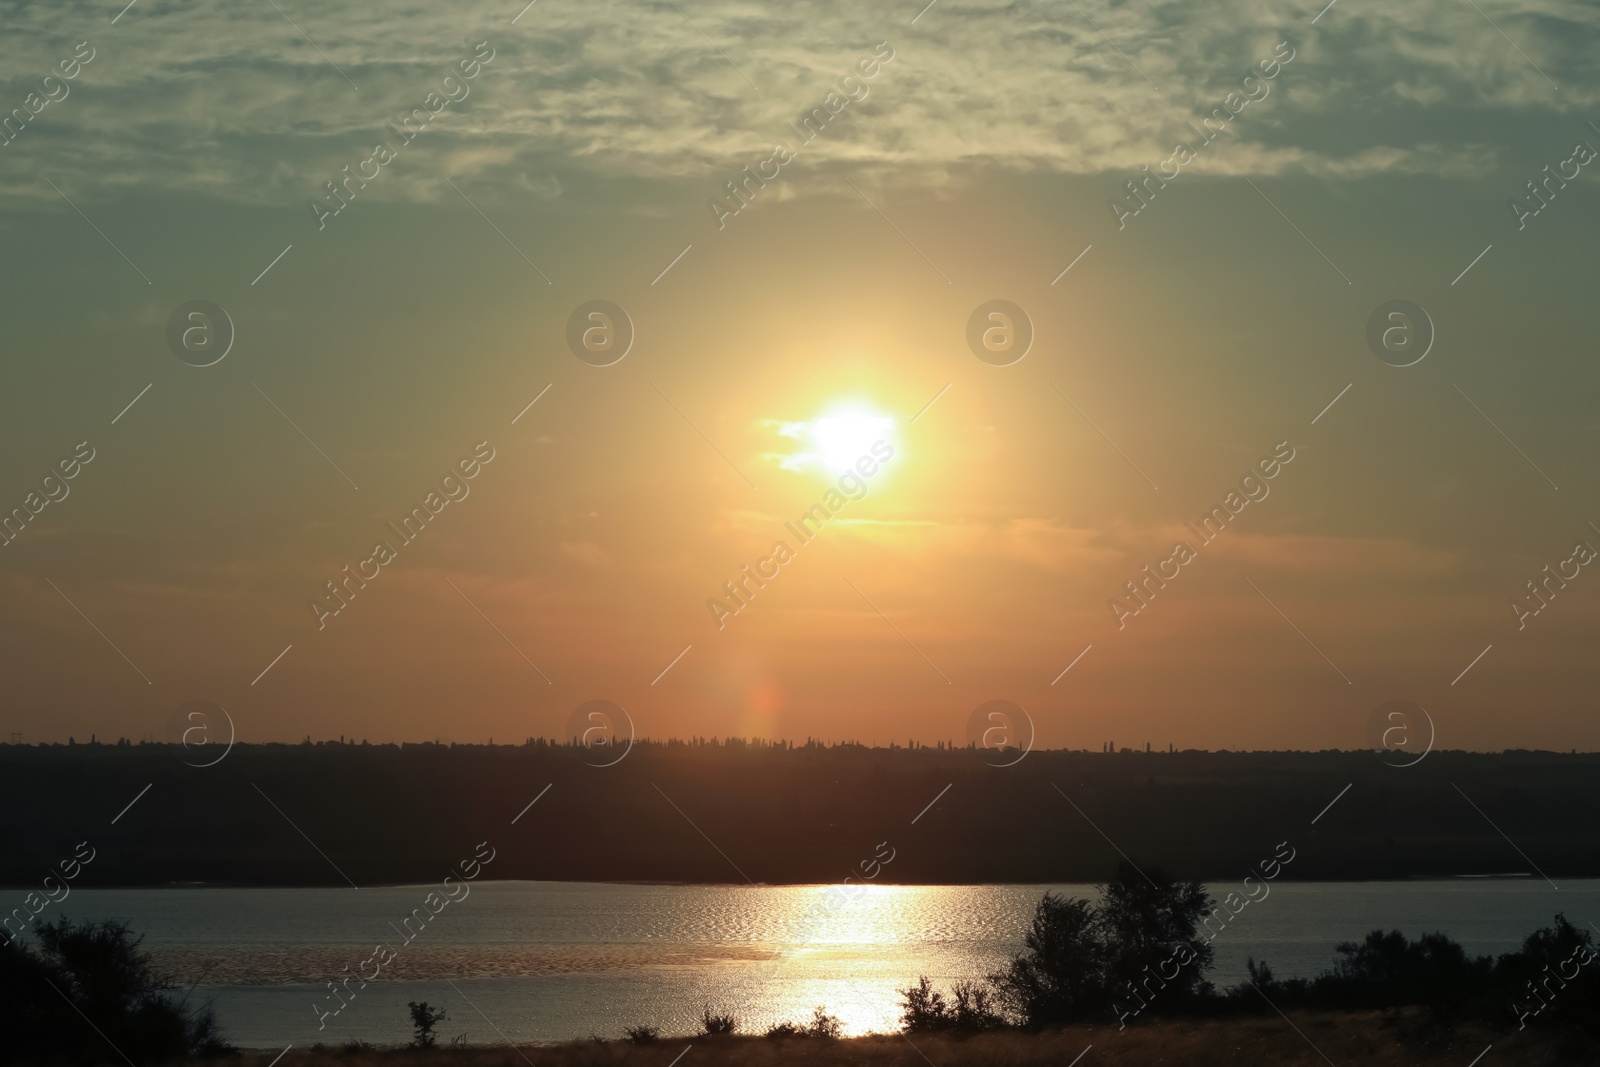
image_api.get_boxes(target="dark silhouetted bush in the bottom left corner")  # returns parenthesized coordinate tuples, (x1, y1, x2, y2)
(0, 918, 234, 1065)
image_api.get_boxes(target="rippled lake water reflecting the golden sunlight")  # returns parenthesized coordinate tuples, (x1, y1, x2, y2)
(28, 878, 1600, 1048)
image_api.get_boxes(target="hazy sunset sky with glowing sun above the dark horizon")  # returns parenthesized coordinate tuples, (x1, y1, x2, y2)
(0, 0, 1600, 750)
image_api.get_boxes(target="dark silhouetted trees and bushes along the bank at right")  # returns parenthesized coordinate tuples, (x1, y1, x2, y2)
(901, 864, 1600, 1037)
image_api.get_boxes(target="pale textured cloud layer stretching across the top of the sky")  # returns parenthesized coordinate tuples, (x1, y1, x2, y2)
(0, 0, 1600, 203)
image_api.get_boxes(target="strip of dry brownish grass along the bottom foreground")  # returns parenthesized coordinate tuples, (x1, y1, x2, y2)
(228, 1013, 1600, 1067)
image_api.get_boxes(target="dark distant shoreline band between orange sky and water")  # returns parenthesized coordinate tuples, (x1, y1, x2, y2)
(0, 741, 1600, 889)
